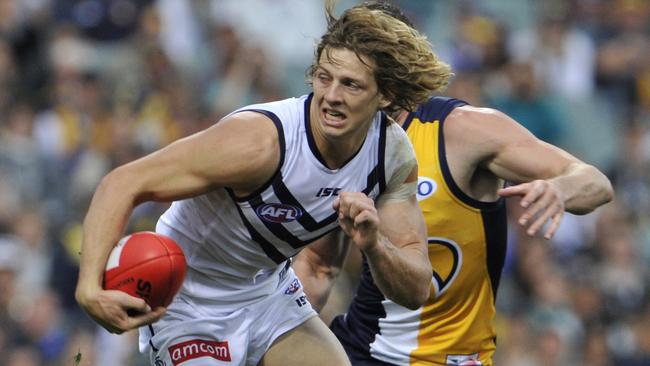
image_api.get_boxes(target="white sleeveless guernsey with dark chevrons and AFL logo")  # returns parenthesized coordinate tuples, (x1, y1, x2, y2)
(157, 95, 415, 306)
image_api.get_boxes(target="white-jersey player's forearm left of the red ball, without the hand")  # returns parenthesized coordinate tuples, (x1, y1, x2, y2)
(77, 170, 139, 300)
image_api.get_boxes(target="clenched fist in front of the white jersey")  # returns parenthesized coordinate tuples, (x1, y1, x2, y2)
(333, 192, 379, 250)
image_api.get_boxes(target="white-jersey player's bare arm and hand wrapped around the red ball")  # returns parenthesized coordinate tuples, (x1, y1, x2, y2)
(75, 112, 279, 333)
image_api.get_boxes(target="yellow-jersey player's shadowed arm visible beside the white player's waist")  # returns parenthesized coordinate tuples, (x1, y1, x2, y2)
(292, 230, 350, 312)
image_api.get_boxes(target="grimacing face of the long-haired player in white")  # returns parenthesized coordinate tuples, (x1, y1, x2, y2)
(310, 48, 389, 147)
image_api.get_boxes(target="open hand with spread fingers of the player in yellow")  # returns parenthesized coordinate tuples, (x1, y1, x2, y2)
(497, 179, 564, 239)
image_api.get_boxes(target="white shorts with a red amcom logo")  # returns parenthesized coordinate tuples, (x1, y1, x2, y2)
(140, 268, 317, 366)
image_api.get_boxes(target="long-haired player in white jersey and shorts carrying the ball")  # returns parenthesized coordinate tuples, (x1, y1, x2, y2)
(76, 4, 450, 365)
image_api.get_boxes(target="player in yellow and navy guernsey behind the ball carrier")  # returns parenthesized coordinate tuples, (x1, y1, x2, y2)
(294, 3, 613, 365)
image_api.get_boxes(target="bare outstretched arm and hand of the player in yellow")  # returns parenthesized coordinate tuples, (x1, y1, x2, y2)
(445, 106, 613, 239)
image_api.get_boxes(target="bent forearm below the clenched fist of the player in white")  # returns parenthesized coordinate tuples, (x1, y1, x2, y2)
(364, 235, 432, 309)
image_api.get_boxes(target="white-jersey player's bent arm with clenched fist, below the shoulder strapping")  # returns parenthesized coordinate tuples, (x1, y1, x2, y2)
(335, 167, 432, 309)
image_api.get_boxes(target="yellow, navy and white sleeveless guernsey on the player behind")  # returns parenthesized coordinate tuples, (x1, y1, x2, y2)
(331, 97, 507, 366)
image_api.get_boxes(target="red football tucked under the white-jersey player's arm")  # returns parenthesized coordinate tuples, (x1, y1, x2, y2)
(104, 231, 186, 309)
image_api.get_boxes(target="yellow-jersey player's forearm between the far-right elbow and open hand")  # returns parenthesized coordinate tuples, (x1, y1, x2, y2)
(549, 163, 613, 215)
